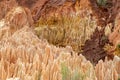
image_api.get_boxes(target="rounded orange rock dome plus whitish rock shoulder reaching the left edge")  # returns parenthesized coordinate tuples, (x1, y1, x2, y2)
(0, 7, 33, 39)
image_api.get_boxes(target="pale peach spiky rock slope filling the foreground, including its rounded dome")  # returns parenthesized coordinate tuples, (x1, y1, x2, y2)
(0, 7, 120, 80)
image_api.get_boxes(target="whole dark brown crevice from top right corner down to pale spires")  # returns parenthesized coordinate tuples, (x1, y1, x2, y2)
(82, 0, 119, 65)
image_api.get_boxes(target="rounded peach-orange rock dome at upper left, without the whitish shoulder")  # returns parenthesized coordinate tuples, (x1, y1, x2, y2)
(5, 7, 33, 29)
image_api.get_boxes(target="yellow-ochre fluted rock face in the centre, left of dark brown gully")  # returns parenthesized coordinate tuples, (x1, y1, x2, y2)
(35, 11, 97, 52)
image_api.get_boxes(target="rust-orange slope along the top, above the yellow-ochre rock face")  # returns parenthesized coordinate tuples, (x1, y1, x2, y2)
(0, 0, 97, 21)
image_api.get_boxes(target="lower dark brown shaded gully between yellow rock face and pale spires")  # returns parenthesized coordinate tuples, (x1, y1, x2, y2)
(82, 28, 108, 65)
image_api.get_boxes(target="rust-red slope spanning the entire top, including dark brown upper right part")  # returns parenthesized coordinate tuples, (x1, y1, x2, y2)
(0, 0, 119, 26)
